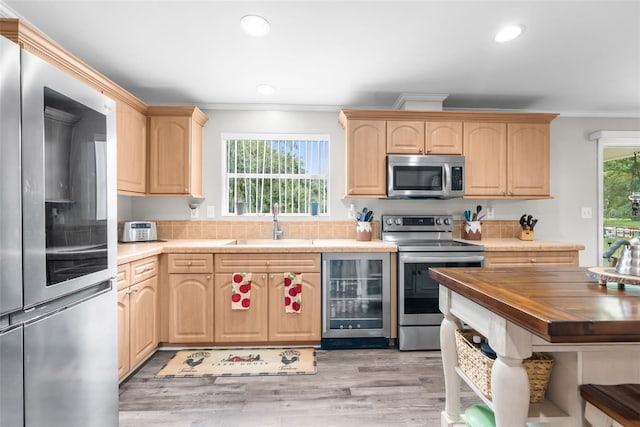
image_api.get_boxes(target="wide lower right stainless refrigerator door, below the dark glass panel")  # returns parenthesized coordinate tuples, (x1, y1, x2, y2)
(23, 282, 118, 427)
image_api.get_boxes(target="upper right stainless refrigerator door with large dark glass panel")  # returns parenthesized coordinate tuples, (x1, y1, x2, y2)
(20, 46, 117, 308)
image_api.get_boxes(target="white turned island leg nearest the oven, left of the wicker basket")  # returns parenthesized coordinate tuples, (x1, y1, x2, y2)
(440, 314, 462, 427)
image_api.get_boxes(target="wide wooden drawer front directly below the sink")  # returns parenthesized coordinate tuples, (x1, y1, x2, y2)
(215, 253, 320, 274)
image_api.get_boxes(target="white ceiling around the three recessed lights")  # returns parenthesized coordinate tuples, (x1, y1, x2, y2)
(0, 0, 640, 117)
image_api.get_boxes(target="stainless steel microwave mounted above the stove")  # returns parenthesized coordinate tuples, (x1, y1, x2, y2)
(387, 155, 464, 199)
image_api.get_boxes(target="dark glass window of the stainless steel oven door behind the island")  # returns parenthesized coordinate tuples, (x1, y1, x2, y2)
(402, 261, 481, 314)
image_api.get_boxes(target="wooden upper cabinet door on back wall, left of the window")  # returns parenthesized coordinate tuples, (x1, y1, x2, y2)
(149, 116, 191, 194)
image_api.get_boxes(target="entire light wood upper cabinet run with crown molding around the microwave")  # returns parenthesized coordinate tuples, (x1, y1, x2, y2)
(338, 109, 557, 199)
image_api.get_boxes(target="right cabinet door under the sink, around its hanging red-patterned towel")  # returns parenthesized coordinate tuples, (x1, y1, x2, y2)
(269, 273, 322, 342)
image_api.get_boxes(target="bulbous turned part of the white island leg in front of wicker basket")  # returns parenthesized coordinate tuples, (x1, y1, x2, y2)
(491, 356, 529, 427)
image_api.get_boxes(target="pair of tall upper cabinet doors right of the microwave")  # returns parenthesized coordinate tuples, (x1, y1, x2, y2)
(464, 122, 550, 199)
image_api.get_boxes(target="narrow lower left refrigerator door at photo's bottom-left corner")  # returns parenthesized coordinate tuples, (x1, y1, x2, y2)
(0, 326, 23, 426)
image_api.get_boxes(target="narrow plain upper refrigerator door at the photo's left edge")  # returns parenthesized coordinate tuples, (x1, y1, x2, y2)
(0, 36, 22, 316)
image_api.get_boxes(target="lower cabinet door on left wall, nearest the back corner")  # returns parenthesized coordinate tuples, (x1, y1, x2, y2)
(129, 277, 158, 368)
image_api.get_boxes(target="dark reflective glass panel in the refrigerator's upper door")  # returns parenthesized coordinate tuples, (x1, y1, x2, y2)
(44, 88, 107, 286)
